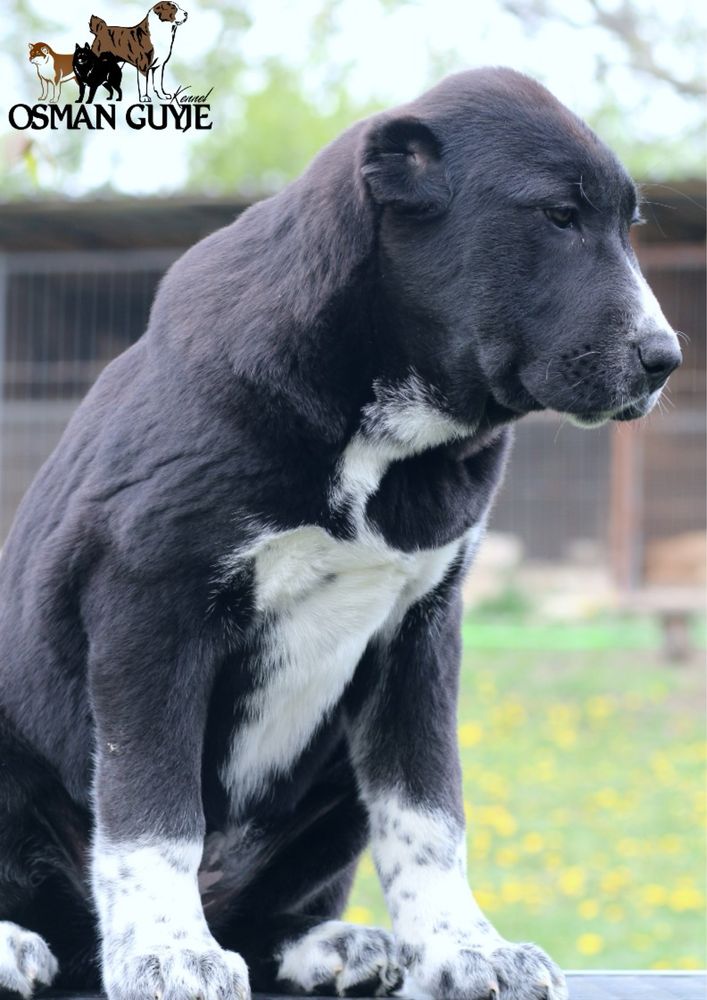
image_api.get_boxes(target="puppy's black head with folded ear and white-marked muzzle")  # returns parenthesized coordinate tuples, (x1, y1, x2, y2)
(360, 69, 681, 425)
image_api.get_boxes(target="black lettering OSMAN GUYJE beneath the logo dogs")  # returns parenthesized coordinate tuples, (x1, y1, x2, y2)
(8, 87, 213, 132)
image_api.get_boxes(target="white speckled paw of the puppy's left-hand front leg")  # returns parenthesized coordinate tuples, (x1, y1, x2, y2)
(103, 942, 250, 1000)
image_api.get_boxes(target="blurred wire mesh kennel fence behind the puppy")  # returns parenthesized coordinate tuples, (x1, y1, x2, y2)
(0, 235, 705, 575)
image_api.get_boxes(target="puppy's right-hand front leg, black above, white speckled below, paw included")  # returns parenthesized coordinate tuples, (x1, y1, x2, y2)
(348, 579, 567, 1000)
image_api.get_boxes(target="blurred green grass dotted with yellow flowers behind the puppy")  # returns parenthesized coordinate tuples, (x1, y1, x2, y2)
(348, 617, 707, 969)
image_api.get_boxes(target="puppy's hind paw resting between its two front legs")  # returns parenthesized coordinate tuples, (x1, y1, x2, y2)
(277, 920, 403, 997)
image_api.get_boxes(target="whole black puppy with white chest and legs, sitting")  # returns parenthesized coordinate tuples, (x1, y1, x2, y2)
(0, 70, 680, 1000)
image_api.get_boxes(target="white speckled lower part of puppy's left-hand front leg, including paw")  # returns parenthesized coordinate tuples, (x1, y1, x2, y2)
(93, 836, 250, 1000)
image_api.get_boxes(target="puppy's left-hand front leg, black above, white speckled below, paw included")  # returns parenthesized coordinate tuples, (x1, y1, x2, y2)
(87, 584, 249, 1000)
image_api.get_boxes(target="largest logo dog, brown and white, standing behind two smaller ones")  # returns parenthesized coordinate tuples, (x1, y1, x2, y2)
(88, 0, 188, 103)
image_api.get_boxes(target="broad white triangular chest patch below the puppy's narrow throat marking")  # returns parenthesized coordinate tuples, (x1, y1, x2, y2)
(221, 526, 462, 807)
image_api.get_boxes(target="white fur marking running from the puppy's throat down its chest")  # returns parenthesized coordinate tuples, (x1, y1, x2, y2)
(220, 373, 480, 812)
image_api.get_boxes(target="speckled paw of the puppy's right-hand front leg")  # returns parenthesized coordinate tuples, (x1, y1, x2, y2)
(401, 943, 568, 1000)
